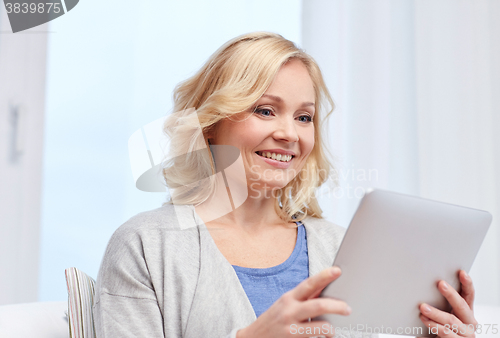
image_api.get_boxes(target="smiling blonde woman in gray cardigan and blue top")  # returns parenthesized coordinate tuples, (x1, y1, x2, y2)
(94, 33, 475, 338)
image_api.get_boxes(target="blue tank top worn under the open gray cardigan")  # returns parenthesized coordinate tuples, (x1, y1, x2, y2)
(233, 222, 309, 317)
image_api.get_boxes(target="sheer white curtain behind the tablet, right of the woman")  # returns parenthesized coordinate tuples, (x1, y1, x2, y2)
(302, 0, 500, 305)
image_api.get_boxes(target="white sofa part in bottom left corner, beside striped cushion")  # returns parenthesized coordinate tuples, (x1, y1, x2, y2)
(0, 302, 68, 338)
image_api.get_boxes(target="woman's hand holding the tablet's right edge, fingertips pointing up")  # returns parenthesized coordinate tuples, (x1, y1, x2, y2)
(420, 270, 477, 338)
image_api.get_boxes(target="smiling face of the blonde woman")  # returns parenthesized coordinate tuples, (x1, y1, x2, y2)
(210, 59, 315, 191)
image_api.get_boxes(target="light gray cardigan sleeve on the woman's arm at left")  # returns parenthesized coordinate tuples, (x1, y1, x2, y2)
(94, 226, 165, 338)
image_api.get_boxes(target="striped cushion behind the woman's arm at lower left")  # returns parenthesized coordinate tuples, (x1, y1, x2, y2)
(65, 268, 95, 338)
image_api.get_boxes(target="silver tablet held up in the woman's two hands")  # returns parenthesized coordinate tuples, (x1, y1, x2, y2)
(315, 190, 492, 337)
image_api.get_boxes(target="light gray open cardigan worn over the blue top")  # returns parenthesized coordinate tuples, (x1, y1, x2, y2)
(94, 205, 345, 338)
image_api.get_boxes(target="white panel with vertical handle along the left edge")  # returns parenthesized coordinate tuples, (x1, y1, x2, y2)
(0, 9, 47, 305)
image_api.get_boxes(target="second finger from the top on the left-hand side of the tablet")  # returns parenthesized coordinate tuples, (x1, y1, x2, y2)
(297, 298, 351, 321)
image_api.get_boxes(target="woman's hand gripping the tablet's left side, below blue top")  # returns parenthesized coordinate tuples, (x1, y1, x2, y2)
(236, 266, 351, 338)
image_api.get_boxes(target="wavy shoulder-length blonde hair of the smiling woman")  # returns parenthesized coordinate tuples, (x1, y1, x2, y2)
(163, 32, 334, 222)
